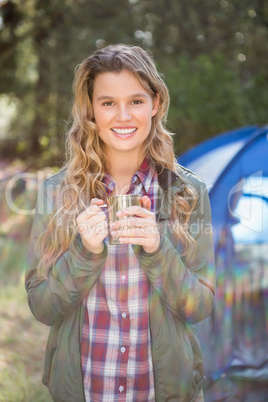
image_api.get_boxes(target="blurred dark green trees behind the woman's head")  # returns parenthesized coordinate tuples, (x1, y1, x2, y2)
(0, 0, 268, 165)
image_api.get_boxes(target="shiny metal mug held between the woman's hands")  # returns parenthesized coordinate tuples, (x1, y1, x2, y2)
(107, 194, 142, 245)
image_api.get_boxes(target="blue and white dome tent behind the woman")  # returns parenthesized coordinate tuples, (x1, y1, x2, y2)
(178, 126, 268, 401)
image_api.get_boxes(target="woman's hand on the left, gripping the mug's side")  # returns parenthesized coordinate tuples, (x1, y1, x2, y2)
(76, 198, 108, 254)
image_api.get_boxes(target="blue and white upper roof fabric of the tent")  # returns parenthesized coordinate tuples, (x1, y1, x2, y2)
(178, 126, 268, 251)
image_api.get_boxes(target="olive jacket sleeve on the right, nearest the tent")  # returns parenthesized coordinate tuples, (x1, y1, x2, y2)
(133, 183, 215, 324)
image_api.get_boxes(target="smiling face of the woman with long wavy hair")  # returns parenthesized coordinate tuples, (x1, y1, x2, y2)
(92, 70, 159, 158)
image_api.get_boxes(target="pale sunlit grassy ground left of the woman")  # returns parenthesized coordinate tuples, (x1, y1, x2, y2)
(0, 163, 52, 402)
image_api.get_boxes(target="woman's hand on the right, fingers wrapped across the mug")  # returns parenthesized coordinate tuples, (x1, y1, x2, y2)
(111, 196, 160, 253)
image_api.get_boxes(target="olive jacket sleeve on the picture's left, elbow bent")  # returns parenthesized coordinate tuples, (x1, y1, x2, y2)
(25, 181, 107, 325)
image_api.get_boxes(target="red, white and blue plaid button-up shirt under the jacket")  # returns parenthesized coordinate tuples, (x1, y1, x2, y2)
(81, 159, 158, 402)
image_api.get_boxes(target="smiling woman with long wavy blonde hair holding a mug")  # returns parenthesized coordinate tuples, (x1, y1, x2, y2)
(26, 45, 214, 402)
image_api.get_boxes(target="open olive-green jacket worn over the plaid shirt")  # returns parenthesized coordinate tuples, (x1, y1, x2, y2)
(26, 166, 215, 402)
